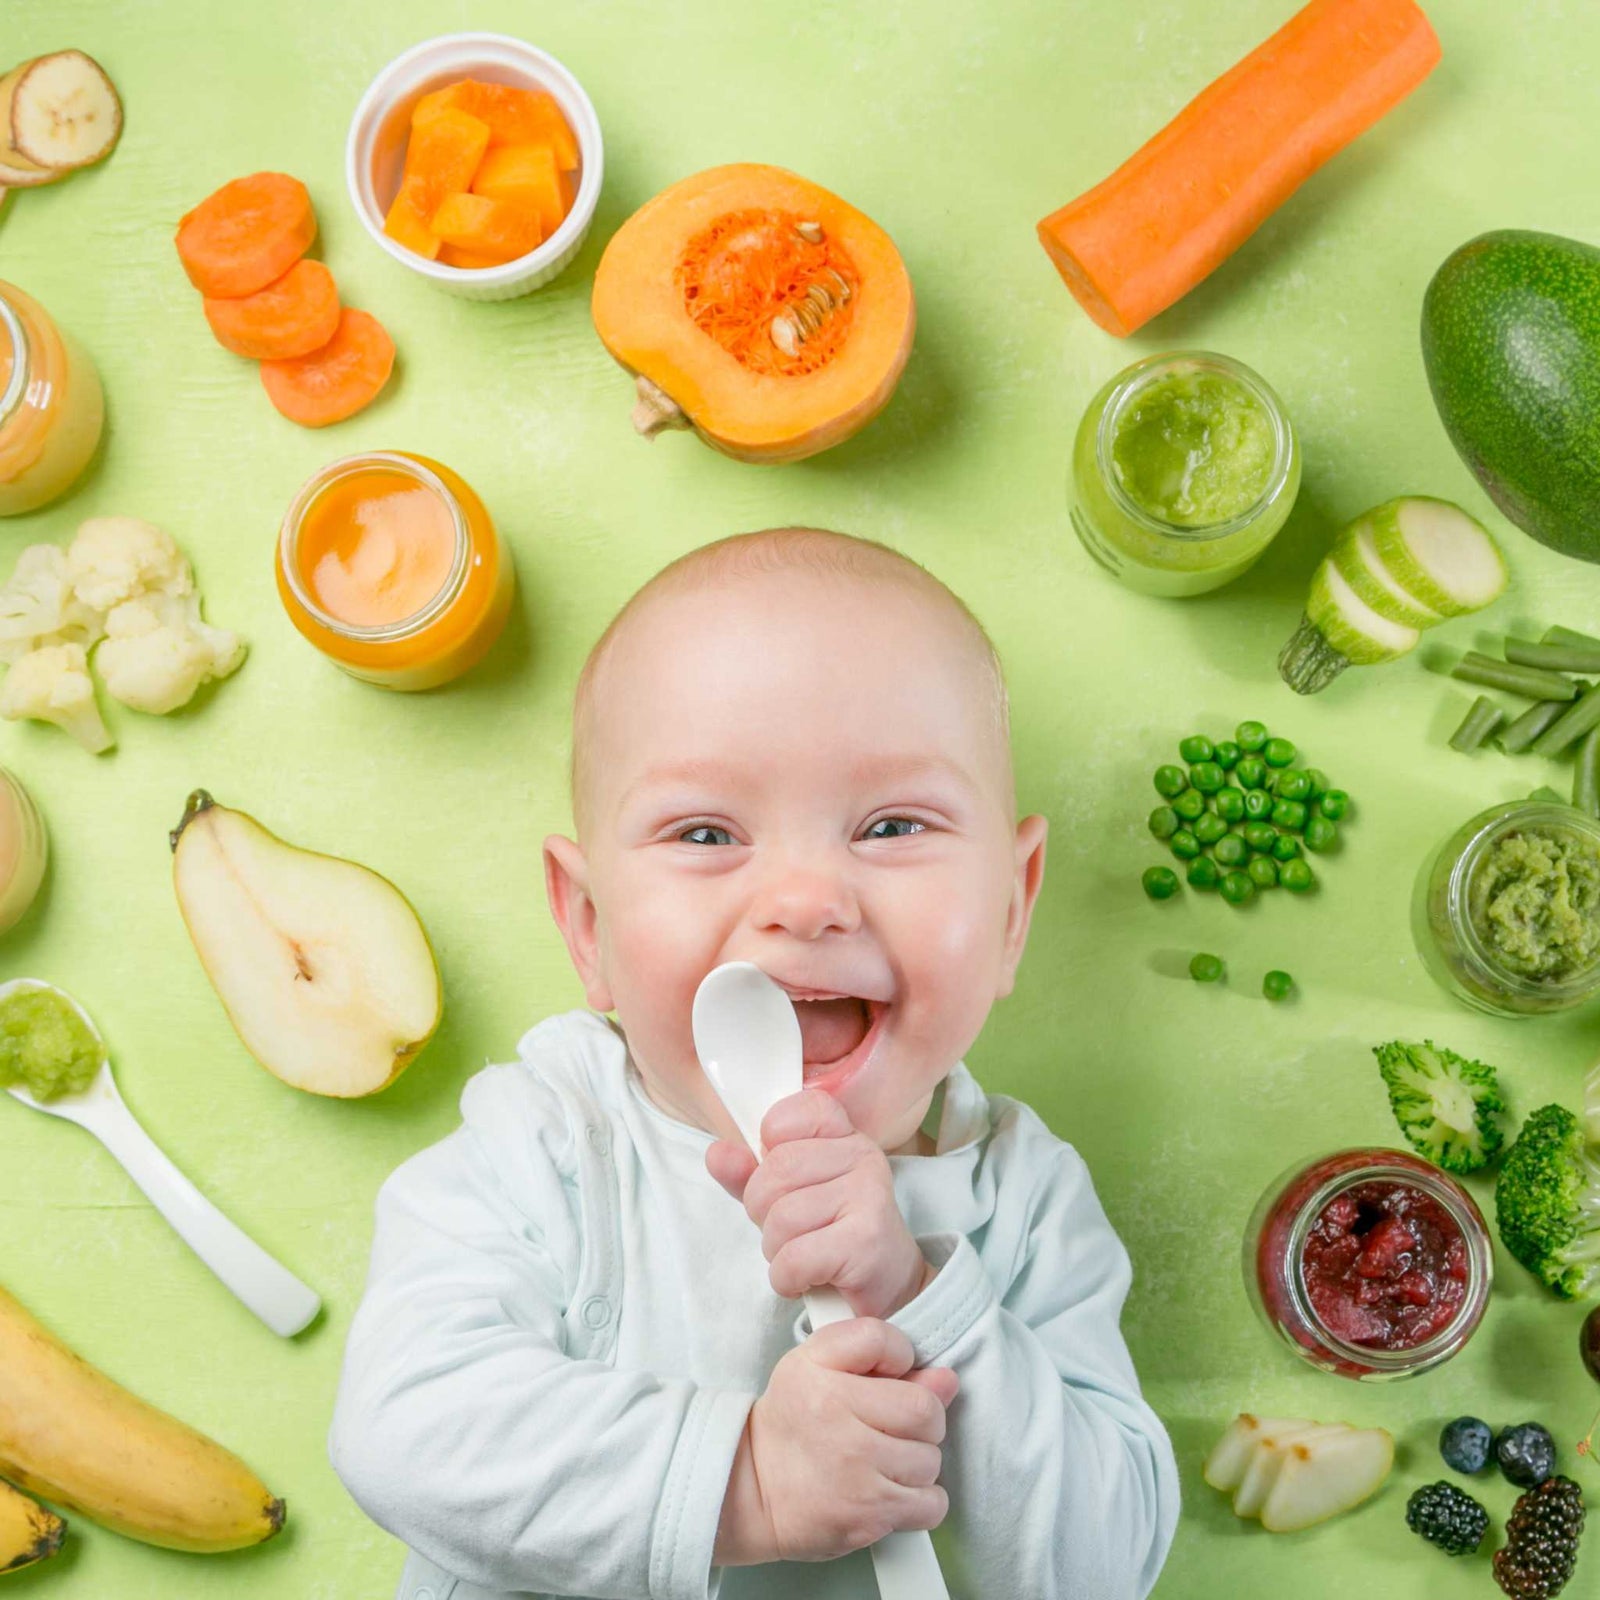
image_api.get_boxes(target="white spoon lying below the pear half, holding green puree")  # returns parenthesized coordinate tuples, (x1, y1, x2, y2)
(0, 978, 322, 1339)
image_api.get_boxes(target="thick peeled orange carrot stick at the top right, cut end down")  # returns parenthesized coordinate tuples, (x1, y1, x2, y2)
(1038, 0, 1440, 334)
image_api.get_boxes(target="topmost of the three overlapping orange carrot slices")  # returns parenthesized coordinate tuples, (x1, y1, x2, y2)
(176, 173, 317, 299)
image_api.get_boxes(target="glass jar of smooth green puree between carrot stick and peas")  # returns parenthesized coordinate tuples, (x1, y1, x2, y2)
(1072, 350, 1301, 597)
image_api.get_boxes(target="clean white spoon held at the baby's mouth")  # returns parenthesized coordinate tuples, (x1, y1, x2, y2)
(691, 962, 949, 1600)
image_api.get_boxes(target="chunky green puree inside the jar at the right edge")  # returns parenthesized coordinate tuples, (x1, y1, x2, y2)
(1467, 827, 1600, 982)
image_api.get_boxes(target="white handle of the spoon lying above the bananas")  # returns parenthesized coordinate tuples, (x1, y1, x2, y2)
(83, 1096, 322, 1339)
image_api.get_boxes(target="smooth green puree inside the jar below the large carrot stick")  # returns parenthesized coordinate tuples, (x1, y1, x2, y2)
(1110, 366, 1277, 528)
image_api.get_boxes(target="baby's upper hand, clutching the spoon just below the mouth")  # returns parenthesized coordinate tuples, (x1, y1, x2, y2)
(706, 1090, 933, 1317)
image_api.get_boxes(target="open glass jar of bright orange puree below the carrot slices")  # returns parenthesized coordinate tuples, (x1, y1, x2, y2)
(278, 450, 515, 690)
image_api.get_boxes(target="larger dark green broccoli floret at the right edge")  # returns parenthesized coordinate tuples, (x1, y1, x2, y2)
(1494, 1106, 1600, 1299)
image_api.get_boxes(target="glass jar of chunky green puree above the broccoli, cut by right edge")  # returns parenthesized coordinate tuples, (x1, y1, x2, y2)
(1411, 800, 1600, 1016)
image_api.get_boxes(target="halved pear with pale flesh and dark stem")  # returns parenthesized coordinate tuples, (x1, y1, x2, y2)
(171, 789, 443, 1099)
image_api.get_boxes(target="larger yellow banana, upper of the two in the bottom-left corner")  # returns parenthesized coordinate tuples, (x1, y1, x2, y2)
(0, 1290, 283, 1550)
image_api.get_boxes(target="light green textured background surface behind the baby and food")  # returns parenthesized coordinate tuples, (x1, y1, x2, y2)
(0, 0, 1600, 1600)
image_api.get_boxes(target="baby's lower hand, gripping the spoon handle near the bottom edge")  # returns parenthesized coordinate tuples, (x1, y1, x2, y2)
(712, 1317, 957, 1566)
